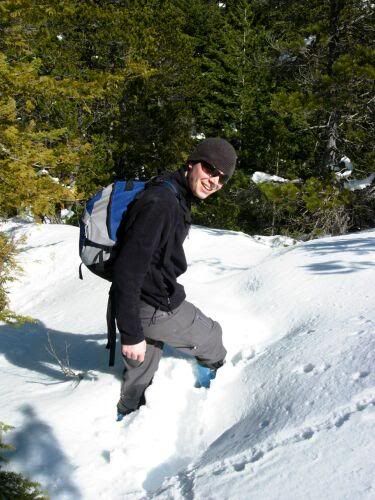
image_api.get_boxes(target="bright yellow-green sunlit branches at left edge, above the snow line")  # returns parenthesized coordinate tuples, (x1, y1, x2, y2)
(0, 52, 80, 217)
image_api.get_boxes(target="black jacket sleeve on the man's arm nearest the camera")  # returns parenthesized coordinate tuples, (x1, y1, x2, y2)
(113, 198, 171, 345)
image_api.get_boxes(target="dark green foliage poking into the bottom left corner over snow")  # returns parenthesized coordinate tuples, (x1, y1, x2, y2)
(0, 422, 48, 500)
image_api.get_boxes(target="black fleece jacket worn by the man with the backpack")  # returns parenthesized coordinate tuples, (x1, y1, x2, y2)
(112, 169, 192, 345)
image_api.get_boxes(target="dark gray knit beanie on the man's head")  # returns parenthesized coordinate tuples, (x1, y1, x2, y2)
(188, 137, 237, 177)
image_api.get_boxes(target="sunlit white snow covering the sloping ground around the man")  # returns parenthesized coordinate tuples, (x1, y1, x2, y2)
(0, 224, 375, 500)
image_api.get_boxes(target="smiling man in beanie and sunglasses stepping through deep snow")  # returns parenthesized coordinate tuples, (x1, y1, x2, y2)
(112, 138, 237, 420)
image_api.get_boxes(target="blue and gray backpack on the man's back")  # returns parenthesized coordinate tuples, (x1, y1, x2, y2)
(79, 179, 178, 281)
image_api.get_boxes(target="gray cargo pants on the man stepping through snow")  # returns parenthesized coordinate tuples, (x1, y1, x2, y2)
(117, 301, 226, 413)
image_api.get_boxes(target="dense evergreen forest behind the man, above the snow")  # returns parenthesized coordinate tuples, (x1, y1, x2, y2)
(0, 0, 375, 316)
